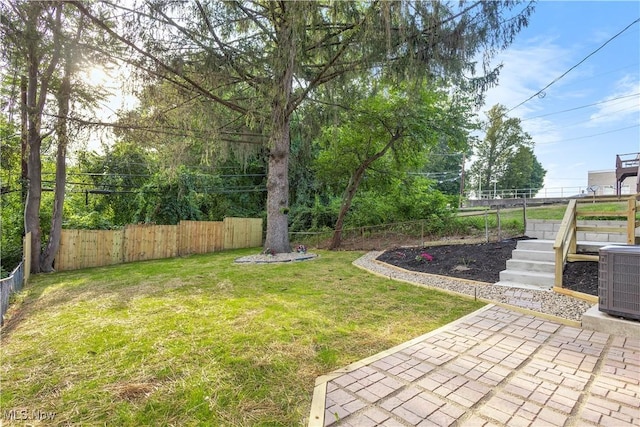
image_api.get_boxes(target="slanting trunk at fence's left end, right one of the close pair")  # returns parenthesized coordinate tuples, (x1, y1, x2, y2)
(40, 41, 71, 273)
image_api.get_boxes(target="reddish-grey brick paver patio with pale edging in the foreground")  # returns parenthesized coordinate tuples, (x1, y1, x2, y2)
(309, 305, 640, 427)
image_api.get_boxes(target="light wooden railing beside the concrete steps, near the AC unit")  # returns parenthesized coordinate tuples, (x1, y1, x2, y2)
(553, 194, 640, 288)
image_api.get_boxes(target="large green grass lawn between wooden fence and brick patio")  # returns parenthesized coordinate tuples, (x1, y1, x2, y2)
(0, 249, 483, 426)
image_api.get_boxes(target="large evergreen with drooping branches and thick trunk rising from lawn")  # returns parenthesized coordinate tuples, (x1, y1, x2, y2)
(72, 0, 532, 252)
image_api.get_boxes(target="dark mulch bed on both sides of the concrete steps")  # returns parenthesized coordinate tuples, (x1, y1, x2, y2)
(378, 237, 598, 296)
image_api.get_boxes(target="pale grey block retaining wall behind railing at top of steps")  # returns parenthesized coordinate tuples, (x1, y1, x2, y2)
(525, 219, 640, 244)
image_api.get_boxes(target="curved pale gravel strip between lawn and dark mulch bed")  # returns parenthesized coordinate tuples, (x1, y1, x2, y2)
(353, 251, 592, 321)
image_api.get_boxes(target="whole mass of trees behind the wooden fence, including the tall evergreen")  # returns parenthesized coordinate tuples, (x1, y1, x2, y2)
(0, 0, 544, 271)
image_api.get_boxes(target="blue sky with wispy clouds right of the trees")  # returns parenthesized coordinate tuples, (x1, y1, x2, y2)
(481, 1, 640, 195)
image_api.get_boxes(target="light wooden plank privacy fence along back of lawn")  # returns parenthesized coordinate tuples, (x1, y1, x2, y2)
(54, 218, 262, 271)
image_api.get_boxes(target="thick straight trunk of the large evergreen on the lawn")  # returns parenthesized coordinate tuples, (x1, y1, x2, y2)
(264, 3, 296, 253)
